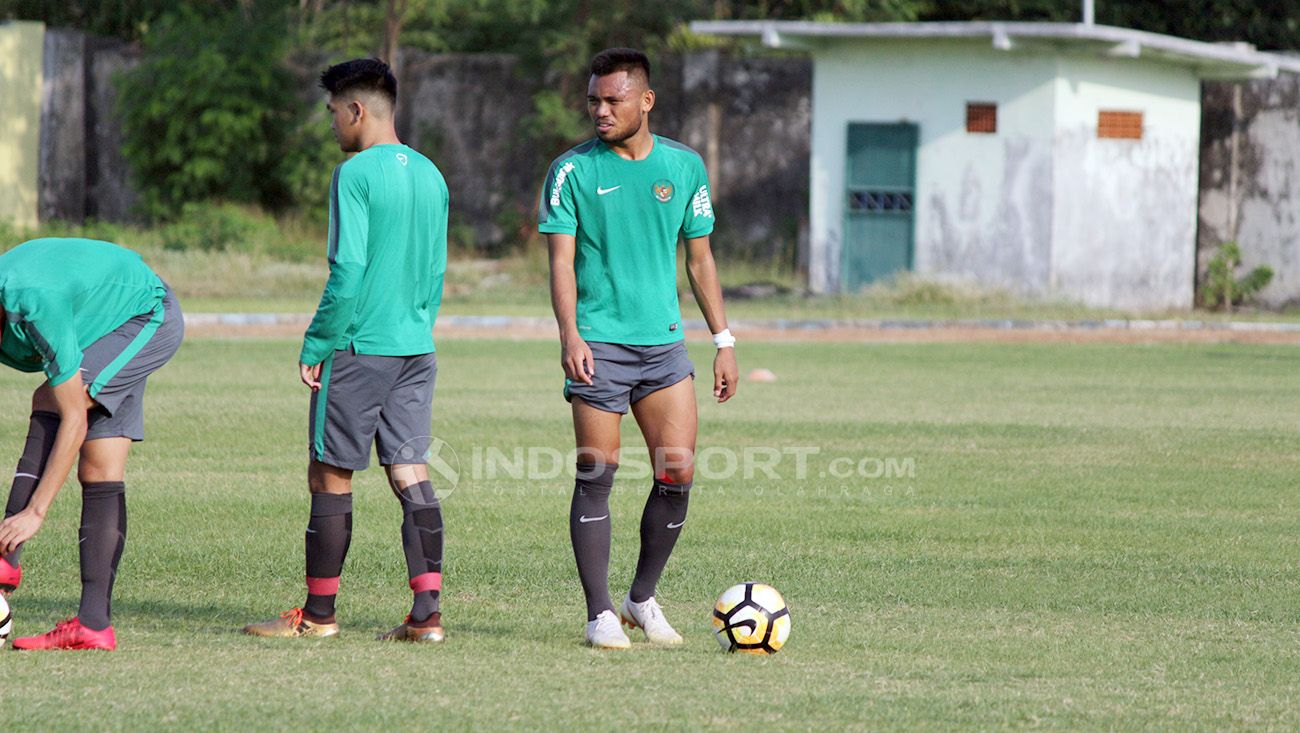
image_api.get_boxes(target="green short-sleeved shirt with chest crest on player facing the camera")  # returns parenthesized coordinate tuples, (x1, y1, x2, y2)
(537, 135, 714, 346)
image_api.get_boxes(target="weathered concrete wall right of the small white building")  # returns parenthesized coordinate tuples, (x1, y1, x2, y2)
(1196, 75, 1300, 308)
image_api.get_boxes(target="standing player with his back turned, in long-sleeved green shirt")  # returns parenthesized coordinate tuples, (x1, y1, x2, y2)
(244, 58, 447, 642)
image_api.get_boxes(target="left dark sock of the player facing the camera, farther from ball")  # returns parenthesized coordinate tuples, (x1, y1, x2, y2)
(569, 463, 619, 621)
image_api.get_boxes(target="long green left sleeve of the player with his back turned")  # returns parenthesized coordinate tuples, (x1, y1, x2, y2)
(299, 164, 371, 367)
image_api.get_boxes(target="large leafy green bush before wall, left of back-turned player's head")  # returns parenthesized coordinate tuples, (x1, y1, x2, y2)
(118, 0, 316, 220)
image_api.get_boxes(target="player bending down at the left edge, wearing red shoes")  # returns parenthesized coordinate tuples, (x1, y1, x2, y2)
(0, 239, 185, 650)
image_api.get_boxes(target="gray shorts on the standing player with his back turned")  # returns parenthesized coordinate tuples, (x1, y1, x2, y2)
(307, 350, 438, 470)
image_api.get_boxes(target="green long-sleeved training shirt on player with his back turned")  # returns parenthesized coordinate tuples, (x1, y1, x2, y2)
(299, 144, 447, 365)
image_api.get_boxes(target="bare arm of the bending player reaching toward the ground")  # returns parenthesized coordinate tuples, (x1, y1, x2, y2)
(0, 370, 94, 555)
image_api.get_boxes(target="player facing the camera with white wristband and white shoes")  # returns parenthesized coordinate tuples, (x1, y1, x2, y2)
(538, 48, 737, 649)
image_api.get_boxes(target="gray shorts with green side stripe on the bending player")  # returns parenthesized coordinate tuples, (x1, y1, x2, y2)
(81, 283, 185, 441)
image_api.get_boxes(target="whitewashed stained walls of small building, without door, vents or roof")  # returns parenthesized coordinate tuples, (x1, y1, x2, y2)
(810, 40, 1199, 308)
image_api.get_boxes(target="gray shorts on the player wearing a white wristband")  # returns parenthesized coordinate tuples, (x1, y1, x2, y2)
(564, 341, 696, 415)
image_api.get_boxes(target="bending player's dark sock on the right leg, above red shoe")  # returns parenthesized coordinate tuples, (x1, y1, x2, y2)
(77, 481, 126, 632)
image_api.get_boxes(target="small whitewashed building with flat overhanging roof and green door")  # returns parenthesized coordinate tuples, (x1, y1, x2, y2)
(692, 21, 1300, 309)
